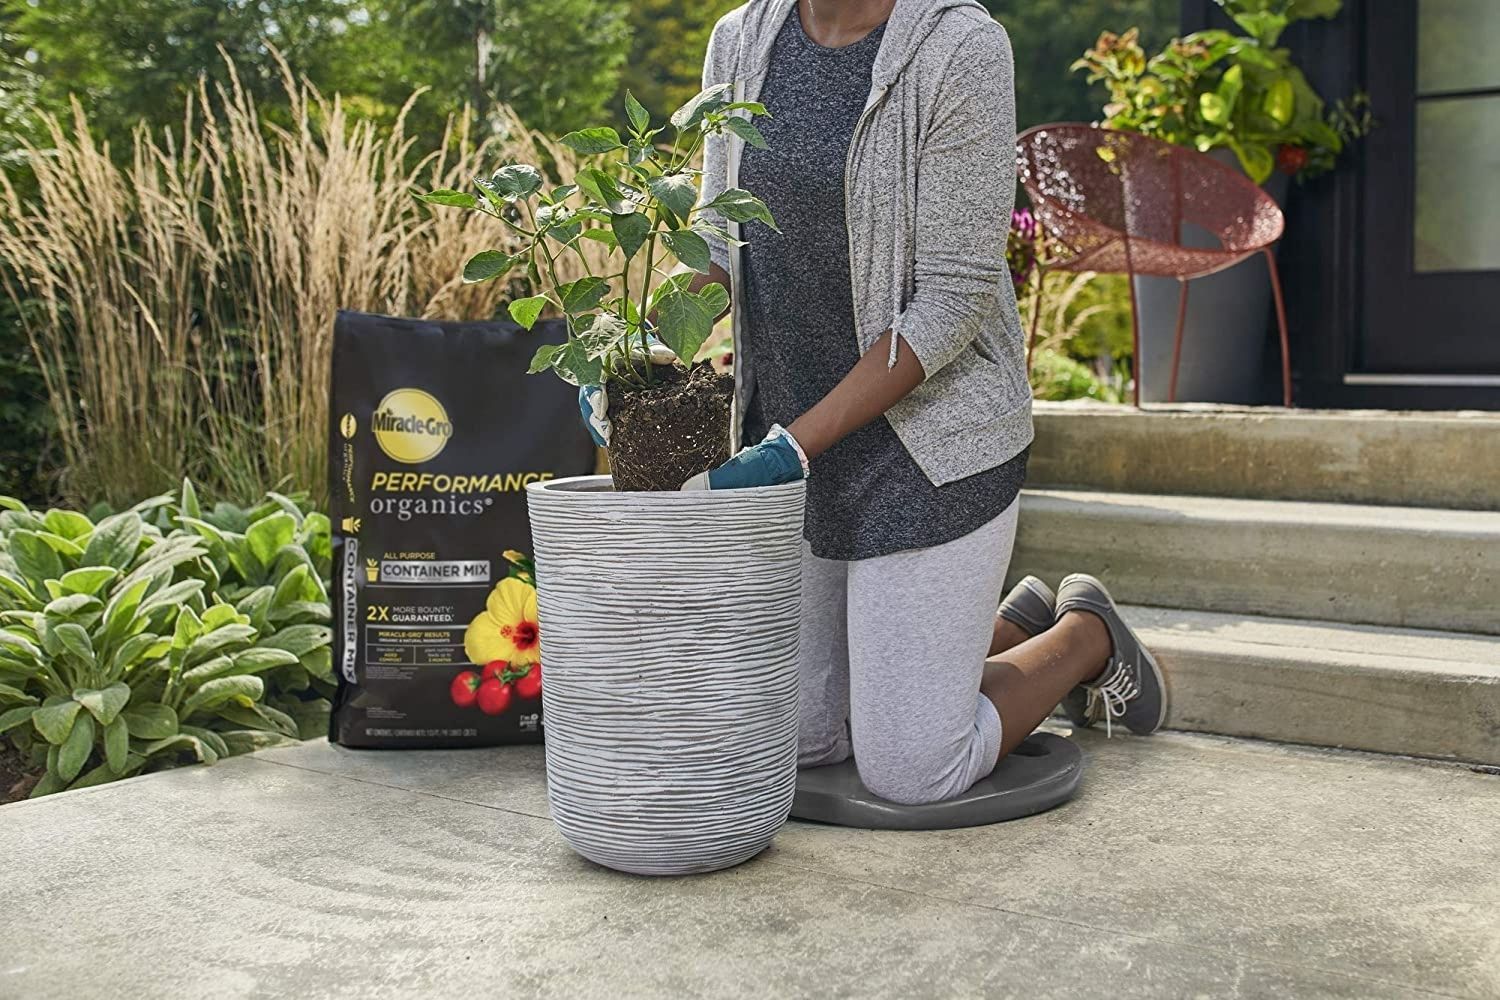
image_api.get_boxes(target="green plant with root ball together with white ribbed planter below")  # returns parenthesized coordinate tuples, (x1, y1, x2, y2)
(425, 87, 806, 874)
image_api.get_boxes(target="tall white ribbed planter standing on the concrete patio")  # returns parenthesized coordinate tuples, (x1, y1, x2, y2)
(527, 475, 806, 876)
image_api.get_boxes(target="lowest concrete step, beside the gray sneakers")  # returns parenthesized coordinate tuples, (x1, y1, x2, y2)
(1121, 607, 1500, 765)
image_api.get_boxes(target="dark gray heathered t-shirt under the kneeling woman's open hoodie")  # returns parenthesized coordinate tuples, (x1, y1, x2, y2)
(737, 7, 1026, 559)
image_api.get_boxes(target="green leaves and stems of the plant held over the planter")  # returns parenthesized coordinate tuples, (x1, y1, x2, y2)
(419, 84, 776, 387)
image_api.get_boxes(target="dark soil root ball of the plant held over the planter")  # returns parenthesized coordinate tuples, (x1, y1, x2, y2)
(609, 361, 735, 492)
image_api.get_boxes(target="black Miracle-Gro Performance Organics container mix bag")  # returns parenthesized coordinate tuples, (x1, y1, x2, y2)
(329, 312, 594, 747)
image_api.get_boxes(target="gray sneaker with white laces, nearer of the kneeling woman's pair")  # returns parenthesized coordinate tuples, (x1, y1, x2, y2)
(1058, 573, 1167, 736)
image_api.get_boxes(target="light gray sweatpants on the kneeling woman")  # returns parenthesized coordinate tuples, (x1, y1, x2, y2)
(798, 504, 1020, 804)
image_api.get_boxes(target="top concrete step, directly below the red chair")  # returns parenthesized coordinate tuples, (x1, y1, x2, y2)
(1028, 402, 1500, 510)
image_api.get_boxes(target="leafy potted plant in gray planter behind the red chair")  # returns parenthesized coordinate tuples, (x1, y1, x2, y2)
(1073, 0, 1371, 403)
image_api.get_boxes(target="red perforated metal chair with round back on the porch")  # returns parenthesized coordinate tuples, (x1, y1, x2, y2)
(1017, 124, 1292, 406)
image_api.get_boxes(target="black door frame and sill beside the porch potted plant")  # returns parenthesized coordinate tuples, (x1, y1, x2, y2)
(1182, 0, 1500, 409)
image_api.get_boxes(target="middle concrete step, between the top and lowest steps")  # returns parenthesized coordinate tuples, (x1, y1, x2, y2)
(1011, 490, 1500, 634)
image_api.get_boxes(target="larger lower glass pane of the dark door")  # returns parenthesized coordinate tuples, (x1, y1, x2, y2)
(1413, 97, 1500, 271)
